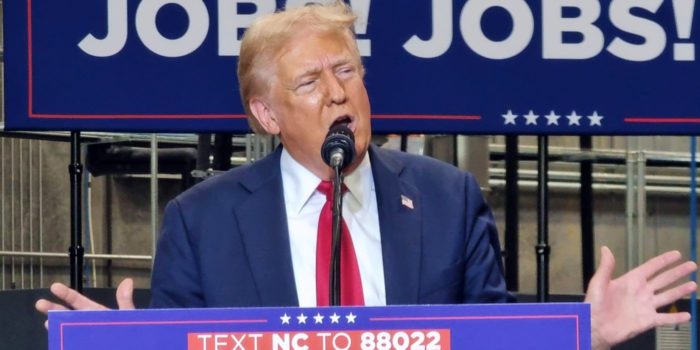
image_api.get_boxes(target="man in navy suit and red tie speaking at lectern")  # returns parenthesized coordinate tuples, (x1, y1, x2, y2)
(37, 2, 696, 349)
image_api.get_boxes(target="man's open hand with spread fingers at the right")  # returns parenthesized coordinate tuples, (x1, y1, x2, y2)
(586, 247, 697, 350)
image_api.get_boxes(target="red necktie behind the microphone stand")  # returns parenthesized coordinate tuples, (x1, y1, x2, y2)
(316, 181, 365, 306)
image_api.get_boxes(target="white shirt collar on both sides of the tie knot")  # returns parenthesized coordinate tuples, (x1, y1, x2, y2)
(280, 148, 374, 214)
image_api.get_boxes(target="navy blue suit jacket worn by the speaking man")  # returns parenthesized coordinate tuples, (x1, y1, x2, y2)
(151, 147, 510, 308)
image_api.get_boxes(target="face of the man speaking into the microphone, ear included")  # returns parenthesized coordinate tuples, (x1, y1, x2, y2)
(251, 29, 371, 179)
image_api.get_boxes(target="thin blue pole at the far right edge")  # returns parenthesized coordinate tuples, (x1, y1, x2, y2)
(690, 136, 698, 349)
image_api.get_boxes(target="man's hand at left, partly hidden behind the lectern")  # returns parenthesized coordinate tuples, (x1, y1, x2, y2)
(34, 278, 135, 329)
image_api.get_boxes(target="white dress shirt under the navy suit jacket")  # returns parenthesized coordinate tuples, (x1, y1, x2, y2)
(280, 149, 386, 307)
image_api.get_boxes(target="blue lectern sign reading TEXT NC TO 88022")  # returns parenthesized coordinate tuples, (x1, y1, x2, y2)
(49, 303, 591, 350)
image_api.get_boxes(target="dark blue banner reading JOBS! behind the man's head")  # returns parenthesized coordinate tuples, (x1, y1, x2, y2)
(2, 0, 700, 135)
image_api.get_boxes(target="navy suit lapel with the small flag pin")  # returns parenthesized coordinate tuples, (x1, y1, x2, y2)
(369, 147, 422, 304)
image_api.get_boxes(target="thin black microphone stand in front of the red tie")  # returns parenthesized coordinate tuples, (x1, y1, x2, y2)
(328, 165, 343, 306)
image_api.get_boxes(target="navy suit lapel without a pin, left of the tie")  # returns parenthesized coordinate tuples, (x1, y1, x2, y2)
(235, 147, 299, 306)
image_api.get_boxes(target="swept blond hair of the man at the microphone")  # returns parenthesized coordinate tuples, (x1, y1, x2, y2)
(238, 0, 361, 134)
